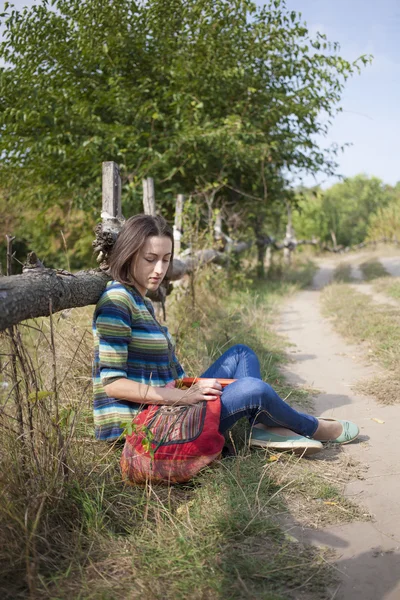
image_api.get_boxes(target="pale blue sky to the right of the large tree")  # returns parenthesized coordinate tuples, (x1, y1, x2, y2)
(0, 0, 400, 187)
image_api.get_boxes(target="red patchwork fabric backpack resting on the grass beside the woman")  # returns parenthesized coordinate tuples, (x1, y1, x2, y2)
(121, 380, 225, 484)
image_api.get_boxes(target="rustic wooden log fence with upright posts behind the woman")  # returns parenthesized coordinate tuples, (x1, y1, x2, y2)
(0, 162, 396, 331)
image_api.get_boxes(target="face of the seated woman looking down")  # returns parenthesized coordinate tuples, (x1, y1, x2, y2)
(131, 235, 172, 296)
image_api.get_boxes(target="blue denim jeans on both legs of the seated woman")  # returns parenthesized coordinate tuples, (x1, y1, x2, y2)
(202, 344, 318, 437)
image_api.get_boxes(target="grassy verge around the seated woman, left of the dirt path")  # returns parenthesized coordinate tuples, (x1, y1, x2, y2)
(0, 263, 362, 600)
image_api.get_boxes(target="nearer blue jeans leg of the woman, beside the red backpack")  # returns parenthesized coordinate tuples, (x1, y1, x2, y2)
(220, 377, 318, 437)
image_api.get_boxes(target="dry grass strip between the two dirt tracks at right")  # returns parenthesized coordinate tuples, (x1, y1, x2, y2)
(322, 280, 400, 404)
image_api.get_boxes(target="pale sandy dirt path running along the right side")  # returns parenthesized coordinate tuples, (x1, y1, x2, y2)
(279, 258, 400, 600)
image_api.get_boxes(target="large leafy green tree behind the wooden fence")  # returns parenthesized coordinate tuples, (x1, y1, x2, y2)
(0, 0, 368, 266)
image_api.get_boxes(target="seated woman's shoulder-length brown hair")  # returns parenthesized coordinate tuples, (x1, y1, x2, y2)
(108, 215, 174, 285)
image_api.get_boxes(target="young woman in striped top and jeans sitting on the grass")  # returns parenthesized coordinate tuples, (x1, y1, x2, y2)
(93, 215, 359, 455)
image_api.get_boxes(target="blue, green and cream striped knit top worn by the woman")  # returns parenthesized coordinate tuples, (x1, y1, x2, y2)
(93, 281, 184, 441)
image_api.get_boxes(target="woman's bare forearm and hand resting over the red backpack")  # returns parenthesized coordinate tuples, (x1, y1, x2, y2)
(104, 377, 222, 406)
